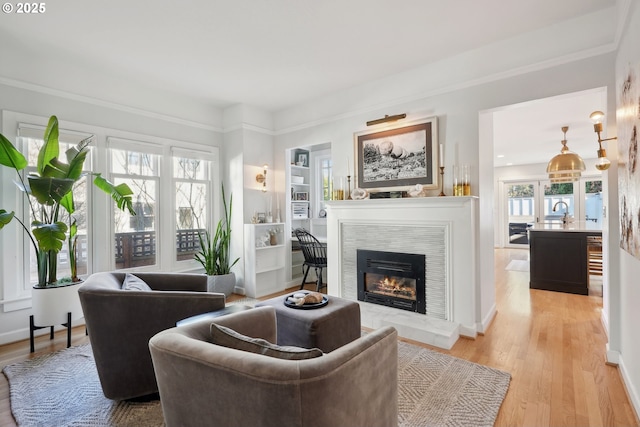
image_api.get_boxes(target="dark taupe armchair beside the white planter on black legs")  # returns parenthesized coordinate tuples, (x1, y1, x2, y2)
(78, 272, 225, 400)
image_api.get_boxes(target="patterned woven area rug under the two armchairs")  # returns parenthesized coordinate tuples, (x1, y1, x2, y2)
(3, 342, 511, 427)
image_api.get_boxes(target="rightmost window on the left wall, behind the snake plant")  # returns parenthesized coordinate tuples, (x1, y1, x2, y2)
(173, 150, 211, 261)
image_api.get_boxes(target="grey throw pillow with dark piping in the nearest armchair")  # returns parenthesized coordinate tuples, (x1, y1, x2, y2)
(211, 323, 323, 360)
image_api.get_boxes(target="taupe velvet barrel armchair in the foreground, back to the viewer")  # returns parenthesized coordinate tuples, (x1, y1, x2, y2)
(149, 306, 398, 427)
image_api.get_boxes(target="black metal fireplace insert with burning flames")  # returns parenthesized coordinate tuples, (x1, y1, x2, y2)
(357, 249, 427, 314)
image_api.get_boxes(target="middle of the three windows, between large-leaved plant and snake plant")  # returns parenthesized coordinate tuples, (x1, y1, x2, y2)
(110, 144, 160, 269)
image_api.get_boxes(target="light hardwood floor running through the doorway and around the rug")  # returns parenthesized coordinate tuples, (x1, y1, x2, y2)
(0, 249, 640, 427)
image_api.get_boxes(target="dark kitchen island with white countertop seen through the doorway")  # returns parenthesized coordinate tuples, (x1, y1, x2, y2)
(529, 221, 602, 295)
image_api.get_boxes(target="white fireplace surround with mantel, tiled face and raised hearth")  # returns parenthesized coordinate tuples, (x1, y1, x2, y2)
(327, 196, 479, 349)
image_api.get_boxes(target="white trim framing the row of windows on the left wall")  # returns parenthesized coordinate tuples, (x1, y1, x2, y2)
(0, 110, 220, 312)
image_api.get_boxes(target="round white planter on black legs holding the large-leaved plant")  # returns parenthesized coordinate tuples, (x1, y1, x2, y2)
(31, 282, 84, 326)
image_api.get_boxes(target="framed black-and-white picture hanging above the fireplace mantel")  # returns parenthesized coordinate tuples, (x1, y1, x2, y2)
(354, 117, 438, 191)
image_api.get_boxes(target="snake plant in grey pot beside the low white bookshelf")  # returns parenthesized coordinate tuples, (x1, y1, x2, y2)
(195, 184, 240, 297)
